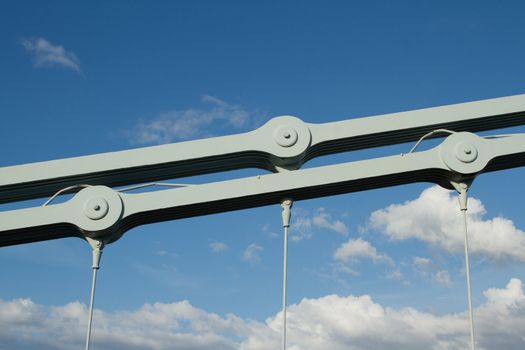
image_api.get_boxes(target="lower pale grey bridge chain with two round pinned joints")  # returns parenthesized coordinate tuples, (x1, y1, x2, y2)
(0, 132, 525, 246)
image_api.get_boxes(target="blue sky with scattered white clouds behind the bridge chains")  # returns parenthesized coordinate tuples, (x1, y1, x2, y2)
(0, 1, 525, 349)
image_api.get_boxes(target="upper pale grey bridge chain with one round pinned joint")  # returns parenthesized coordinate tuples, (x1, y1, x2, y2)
(0, 95, 525, 203)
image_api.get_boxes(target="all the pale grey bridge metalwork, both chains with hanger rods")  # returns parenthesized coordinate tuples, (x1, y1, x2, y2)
(0, 95, 525, 347)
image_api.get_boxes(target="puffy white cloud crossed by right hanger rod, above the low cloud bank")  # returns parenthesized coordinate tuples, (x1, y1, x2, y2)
(370, 186, 525, 261)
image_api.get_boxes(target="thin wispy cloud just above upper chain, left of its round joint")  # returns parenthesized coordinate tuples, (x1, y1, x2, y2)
(126, 95, 250, 144)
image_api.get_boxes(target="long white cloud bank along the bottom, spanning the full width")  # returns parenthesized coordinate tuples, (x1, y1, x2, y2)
(0, 279, 525, 350)
